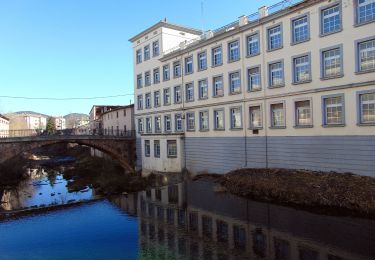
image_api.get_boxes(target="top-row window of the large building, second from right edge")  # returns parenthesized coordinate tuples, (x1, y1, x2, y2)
(320, 4, 341, 35)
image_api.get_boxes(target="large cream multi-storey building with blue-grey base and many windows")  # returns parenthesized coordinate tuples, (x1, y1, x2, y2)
(130, 0, 375, 176)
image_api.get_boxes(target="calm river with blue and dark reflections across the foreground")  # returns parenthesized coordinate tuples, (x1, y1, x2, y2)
(0, 168, 375, 260)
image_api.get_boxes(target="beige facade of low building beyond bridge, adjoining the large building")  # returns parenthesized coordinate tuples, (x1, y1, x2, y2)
(101, 104, 134, 136)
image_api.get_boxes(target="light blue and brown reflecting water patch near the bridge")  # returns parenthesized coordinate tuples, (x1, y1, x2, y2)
(0, 167, 94, 211)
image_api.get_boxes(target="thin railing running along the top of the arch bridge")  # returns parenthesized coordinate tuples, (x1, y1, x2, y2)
(0, 128, 135, 139)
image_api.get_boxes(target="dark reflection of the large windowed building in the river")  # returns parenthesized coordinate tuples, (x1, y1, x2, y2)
(115, 181, 375, 260)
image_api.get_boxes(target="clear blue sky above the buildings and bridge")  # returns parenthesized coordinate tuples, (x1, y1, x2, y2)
(0, 0, 277, 115)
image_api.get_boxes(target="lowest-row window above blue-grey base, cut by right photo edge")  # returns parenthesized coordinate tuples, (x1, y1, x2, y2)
(358, 92, 375, 124)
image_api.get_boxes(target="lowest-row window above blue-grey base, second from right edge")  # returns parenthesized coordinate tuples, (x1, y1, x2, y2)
(322, 95, 344, 126)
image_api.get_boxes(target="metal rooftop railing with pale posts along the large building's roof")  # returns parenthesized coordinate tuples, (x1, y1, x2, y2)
(163, 0, 305, 55)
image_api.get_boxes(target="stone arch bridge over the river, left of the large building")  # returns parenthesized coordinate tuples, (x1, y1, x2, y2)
(0, 135, 136, 172)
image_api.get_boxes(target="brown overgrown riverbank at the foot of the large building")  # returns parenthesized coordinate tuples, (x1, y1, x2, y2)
(197, 169, 375, 218)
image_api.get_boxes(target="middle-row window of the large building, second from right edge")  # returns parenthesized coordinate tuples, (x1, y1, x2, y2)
(322, 47, 342, 79)
